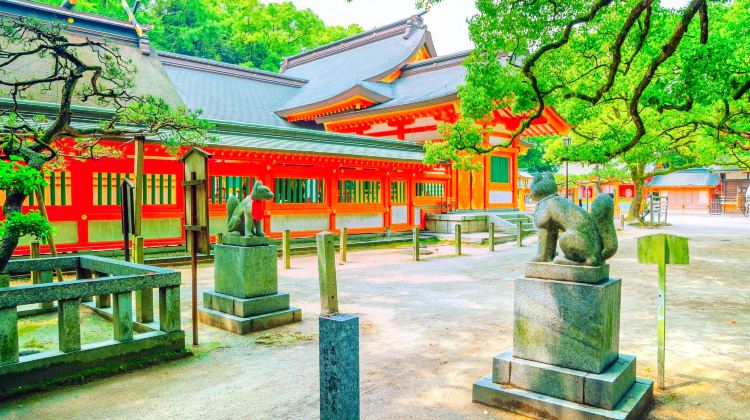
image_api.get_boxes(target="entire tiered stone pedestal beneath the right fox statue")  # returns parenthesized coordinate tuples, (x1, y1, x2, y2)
(473, 263, 653, 419)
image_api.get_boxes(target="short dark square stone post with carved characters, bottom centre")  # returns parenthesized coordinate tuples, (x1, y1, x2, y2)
(318, 314, 359, 420)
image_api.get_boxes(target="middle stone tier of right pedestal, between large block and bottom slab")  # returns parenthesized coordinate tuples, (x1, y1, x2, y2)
(492, 350, 636, 410)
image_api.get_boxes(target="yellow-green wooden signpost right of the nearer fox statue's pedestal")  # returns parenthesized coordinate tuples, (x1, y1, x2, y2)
(638, 233, 690, 389)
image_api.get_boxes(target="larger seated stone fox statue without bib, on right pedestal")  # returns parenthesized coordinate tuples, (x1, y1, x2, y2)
(531, 173, 617, 266)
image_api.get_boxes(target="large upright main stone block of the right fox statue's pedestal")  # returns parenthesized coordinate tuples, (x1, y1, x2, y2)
(513, 277, 622, 373)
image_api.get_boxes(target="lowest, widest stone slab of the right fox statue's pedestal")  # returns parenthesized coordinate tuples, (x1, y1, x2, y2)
(472, 374, 654, 420)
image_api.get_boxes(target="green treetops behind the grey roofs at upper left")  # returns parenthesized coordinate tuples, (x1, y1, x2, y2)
(30, 0, 362, 71)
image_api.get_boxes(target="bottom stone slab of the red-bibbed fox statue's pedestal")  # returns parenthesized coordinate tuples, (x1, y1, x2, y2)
(203, 306, 302, 334)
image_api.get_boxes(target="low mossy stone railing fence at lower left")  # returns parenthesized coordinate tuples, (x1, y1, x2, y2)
(0, 256, 185, 399)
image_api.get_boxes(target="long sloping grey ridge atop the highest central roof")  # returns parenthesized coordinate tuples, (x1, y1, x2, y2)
(281, 10, 435, 73)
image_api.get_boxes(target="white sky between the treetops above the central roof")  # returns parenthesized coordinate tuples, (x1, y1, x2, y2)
(262, 0, 688, 55)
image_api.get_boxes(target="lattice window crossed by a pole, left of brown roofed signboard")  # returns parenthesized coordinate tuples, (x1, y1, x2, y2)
(94, 172, 177, 206)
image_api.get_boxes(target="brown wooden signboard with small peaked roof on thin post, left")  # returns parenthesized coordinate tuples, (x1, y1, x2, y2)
(180, 147, 211, 346)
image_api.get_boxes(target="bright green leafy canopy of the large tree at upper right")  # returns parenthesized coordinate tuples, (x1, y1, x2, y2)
(421, 0, 750, 179)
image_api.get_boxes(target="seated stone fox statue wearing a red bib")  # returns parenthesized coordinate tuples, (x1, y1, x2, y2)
(227, 181, 280, 236)
